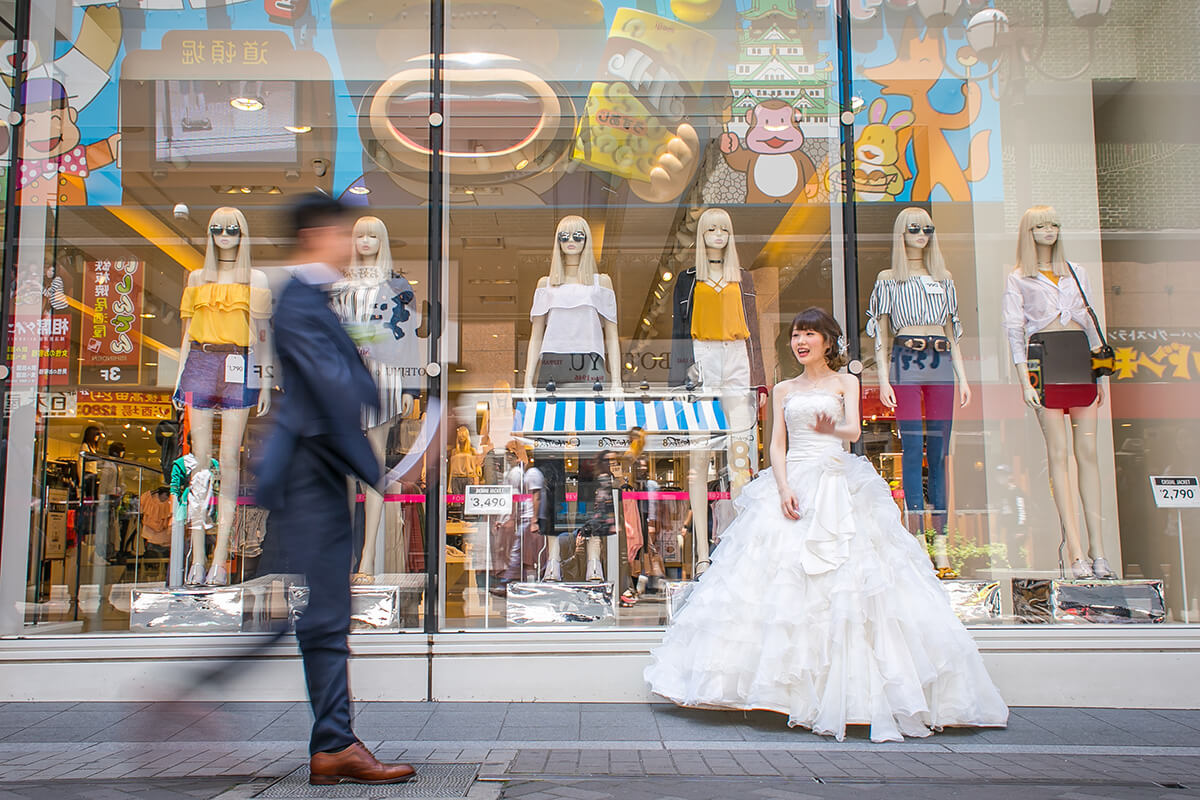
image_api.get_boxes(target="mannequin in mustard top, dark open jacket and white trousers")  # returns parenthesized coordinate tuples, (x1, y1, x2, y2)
(671, 209, 767, 576)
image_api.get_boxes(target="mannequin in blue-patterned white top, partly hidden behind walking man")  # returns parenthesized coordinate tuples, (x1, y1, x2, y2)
(332, 217, 420, 583)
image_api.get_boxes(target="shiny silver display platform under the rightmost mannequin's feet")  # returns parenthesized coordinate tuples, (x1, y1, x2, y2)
(1013, 578, 1166, 625)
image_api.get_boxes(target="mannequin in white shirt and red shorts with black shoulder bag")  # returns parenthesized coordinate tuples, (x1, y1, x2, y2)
(1003, 205, 1116, 578)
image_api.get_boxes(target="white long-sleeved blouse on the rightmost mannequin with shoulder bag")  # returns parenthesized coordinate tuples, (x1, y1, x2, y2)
(1002, 265, 1100, 363)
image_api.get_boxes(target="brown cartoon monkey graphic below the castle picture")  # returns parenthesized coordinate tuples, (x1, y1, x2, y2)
(721, 100, 816, 204)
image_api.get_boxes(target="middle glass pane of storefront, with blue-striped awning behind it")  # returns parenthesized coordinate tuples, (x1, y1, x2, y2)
(444, 0, 842, 630)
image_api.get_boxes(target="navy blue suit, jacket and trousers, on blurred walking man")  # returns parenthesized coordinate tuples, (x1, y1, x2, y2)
(256, 272, 380, 753)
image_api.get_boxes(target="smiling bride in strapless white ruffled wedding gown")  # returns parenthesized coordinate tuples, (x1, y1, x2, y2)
(646, 308, 1008, 741)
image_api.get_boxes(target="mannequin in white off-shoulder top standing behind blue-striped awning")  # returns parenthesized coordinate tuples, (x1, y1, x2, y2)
(524, 216, 620, 581)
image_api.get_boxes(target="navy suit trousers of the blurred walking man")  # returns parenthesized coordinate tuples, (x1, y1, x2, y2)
(263, 438, 358, 753)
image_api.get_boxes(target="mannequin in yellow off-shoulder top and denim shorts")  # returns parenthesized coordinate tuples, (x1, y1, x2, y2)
(173, 207, 274, 585)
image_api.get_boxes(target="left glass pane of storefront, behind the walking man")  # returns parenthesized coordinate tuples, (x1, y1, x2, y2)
(4, 0, 430, 633)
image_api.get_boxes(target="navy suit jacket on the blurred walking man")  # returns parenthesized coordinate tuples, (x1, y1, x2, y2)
(256, 278, 380, 509)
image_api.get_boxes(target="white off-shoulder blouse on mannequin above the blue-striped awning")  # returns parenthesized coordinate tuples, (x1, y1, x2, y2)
(529, 275, 617, 356)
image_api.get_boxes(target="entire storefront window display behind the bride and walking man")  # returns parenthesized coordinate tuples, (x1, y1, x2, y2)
(0, 0, 1200, 634)
